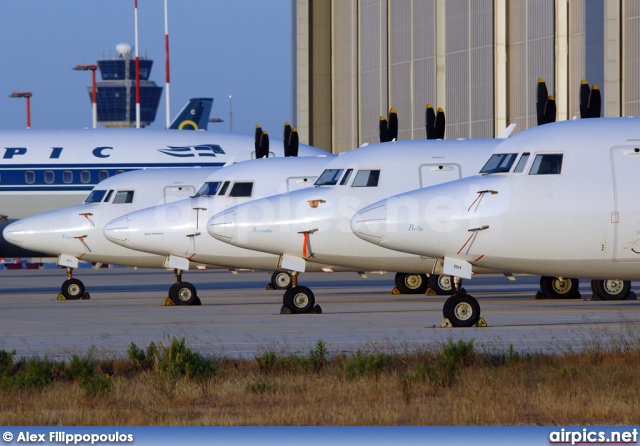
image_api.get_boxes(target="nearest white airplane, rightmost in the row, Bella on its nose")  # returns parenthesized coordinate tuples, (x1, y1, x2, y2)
(351, 118, 640, 326)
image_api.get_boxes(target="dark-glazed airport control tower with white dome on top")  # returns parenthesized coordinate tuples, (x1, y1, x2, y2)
(88, 43, 162, 127)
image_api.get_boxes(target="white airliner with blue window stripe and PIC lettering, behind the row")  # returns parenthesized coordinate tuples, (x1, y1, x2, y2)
(0, 117, 326, 257)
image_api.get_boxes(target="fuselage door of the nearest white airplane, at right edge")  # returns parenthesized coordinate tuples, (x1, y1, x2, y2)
(611, 147, 640, 262)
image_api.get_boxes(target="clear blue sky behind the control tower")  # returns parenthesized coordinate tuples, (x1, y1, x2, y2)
(0, 0, 295, 136)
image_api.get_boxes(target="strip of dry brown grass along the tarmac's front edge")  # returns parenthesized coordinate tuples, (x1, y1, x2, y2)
(0, 334, 640, 425)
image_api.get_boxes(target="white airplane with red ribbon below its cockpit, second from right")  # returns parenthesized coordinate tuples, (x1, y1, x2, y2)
(207, 134, 512, 313)
